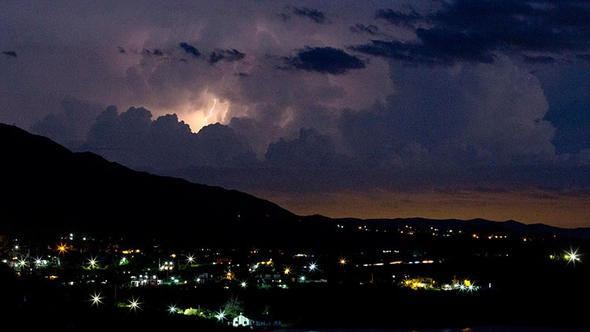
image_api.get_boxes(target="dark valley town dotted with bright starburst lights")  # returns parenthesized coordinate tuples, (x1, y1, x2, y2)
(1, 215, 590, 330)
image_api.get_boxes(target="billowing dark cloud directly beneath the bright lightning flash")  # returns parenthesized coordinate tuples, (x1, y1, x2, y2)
(79, 106, 256, 171)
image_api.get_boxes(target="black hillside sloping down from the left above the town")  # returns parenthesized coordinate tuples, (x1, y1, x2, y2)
(0, 124, 306, 245)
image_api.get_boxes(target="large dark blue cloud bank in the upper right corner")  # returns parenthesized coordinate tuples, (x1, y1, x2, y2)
(354, 0, 590, 64)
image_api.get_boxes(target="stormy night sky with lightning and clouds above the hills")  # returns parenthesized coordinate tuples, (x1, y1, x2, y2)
(0, 0, 590, 227)
